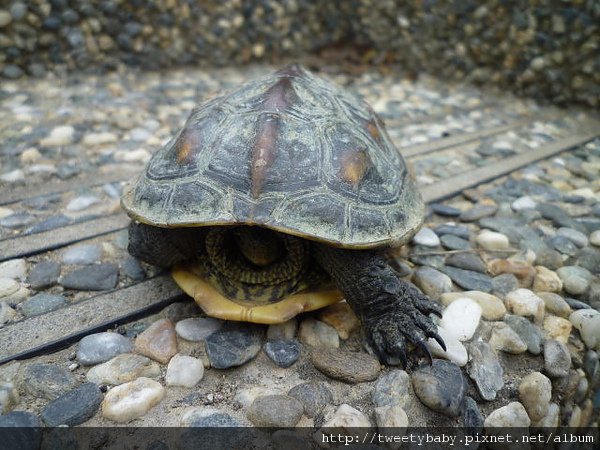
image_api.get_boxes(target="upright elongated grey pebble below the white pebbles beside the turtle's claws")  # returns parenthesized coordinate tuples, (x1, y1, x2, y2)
(467, 342, 504, 401)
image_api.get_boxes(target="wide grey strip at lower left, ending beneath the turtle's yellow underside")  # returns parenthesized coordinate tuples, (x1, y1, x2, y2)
(0, 274, 184, 364)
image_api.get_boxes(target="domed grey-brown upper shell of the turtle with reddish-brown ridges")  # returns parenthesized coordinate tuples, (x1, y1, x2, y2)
(122, 64, 424, 248)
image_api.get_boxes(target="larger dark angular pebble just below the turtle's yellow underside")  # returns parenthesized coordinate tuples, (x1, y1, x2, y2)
(205, 322, 262, 369)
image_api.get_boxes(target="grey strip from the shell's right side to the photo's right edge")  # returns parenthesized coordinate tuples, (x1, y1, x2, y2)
(420, 130, 600, 203)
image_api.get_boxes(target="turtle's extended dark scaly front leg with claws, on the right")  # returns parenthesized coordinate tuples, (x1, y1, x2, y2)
(314, 244, 445, 367)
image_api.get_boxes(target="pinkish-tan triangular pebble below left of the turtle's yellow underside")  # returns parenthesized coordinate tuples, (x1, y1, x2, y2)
(135, 319, 177, 364)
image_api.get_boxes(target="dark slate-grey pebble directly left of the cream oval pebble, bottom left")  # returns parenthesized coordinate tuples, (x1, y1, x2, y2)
(41, 383, 102, 427)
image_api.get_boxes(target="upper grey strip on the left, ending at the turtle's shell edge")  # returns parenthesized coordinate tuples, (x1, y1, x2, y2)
(0, 213, 129, 261)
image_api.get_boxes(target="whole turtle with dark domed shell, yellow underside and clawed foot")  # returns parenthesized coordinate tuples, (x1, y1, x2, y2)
(121, 64, 445, 366)
